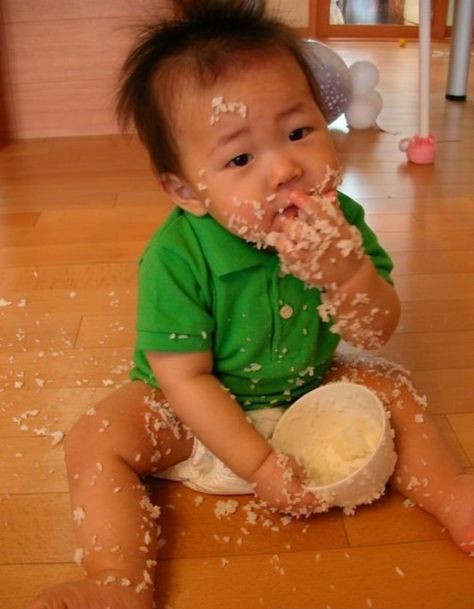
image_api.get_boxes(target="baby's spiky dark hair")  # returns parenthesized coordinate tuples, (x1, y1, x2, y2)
(117, 0, 316, 173)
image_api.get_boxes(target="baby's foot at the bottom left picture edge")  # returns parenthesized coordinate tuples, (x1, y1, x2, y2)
(28, 575, 155, 609)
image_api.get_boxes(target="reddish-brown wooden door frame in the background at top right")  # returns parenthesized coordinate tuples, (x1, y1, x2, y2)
(308, 0, 451, 40)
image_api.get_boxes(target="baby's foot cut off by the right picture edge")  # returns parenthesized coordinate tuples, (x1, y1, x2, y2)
(438, 474, 474, 556)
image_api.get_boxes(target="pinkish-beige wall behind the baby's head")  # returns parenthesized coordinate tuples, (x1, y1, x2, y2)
(1, 0, 309, 138)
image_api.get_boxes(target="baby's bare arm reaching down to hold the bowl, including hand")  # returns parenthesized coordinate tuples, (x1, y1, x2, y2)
(148, 351, 318, 515)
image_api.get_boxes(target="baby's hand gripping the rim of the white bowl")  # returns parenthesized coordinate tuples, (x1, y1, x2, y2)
(250, 451, 327, 517)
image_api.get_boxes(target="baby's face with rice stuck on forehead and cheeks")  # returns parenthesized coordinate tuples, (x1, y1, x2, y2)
(168, 54, 339, 243)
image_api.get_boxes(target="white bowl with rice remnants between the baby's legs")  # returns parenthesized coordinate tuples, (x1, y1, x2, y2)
(271, 382, 397, 513)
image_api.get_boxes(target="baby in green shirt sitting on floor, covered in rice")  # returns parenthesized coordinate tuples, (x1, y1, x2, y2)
(30, 0, 474, 609)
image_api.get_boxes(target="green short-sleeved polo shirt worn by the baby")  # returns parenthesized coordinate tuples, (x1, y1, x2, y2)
(131, 194, 392, 410)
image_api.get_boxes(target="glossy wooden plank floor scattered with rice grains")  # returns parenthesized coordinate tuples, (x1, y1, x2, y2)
(0, 42, 474, 609)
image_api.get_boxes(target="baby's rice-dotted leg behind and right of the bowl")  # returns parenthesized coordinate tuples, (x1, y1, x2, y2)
(326, 357, 474, 552)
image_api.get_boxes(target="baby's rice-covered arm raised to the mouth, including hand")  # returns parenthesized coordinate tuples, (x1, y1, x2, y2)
(271, 192, 400, 349)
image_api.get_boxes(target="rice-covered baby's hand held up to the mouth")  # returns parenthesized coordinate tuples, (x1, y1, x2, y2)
(267, 191, 364, 289)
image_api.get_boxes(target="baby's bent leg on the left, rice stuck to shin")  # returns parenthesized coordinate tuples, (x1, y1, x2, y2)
(30, 382, 193, 609)
